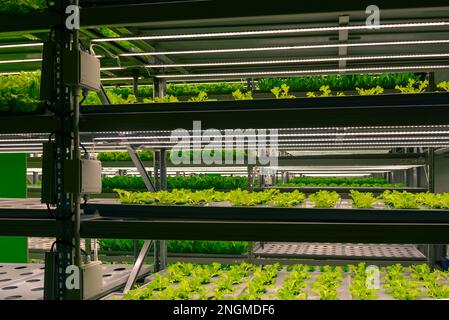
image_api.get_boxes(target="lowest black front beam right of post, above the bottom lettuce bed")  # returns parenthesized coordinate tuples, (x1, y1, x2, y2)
(81, 220, 449, 244)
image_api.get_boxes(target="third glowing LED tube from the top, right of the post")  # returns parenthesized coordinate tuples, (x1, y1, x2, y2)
(156, 65, 449, 79)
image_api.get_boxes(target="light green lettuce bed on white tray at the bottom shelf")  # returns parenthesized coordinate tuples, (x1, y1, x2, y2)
(124, 263, 449, 300)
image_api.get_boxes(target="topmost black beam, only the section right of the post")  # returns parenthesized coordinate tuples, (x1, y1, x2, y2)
(81, 0, 448, 27)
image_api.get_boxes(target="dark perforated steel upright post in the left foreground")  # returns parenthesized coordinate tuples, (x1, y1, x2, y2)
(44, 0, 83, 300)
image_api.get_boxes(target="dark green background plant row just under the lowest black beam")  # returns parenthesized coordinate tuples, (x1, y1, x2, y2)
(98, 239, 248, 255)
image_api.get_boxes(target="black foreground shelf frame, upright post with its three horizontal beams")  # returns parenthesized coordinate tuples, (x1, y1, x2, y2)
(0, 0, 449, 299)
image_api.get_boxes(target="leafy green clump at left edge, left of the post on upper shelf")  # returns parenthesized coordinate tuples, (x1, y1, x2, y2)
(0, 71, 40, 112)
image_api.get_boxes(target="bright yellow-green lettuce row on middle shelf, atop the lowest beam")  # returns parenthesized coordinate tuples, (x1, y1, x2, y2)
(114, 189, 449, 210)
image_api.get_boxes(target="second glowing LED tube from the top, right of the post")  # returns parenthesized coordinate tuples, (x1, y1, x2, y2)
(120, 39, 449, 57)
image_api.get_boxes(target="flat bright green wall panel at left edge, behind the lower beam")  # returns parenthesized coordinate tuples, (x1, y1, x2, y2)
(0, 154, 28, 263)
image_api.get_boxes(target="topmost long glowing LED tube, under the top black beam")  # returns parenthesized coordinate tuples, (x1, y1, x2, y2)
(92, 21, 449, 42)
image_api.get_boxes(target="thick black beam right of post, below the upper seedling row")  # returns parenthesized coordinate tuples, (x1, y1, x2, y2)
(80, 93, 449, 132)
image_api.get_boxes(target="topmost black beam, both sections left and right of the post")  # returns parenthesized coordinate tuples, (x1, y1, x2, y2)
(0, 0, 448, 33)
